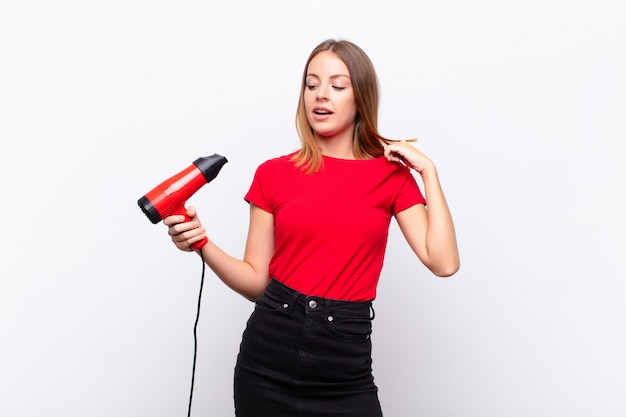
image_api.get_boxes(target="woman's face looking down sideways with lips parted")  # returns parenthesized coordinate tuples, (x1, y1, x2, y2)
(304, 51, 357, 141)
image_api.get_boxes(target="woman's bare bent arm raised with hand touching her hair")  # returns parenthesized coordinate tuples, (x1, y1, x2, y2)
(385, 142, 460, 277)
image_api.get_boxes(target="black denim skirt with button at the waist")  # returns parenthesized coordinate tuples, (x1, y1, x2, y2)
(234, 280, 382, 417)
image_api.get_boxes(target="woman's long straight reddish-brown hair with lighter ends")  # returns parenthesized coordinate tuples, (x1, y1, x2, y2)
(293, 39, 392, 173)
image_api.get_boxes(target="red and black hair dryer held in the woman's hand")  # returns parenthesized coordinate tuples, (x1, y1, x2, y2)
(137, 154, 228, 250)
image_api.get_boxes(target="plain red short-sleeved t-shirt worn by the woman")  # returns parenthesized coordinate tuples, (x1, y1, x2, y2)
(245, 154, 426, 301)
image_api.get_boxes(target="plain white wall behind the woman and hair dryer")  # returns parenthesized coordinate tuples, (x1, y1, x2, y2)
(0, 0, 626, 417)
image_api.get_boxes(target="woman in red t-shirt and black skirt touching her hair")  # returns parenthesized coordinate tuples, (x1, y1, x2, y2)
(164, 39, 459, 417)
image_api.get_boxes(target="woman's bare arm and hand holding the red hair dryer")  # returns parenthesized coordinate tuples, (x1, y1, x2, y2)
(163, 204, 274, 301)
